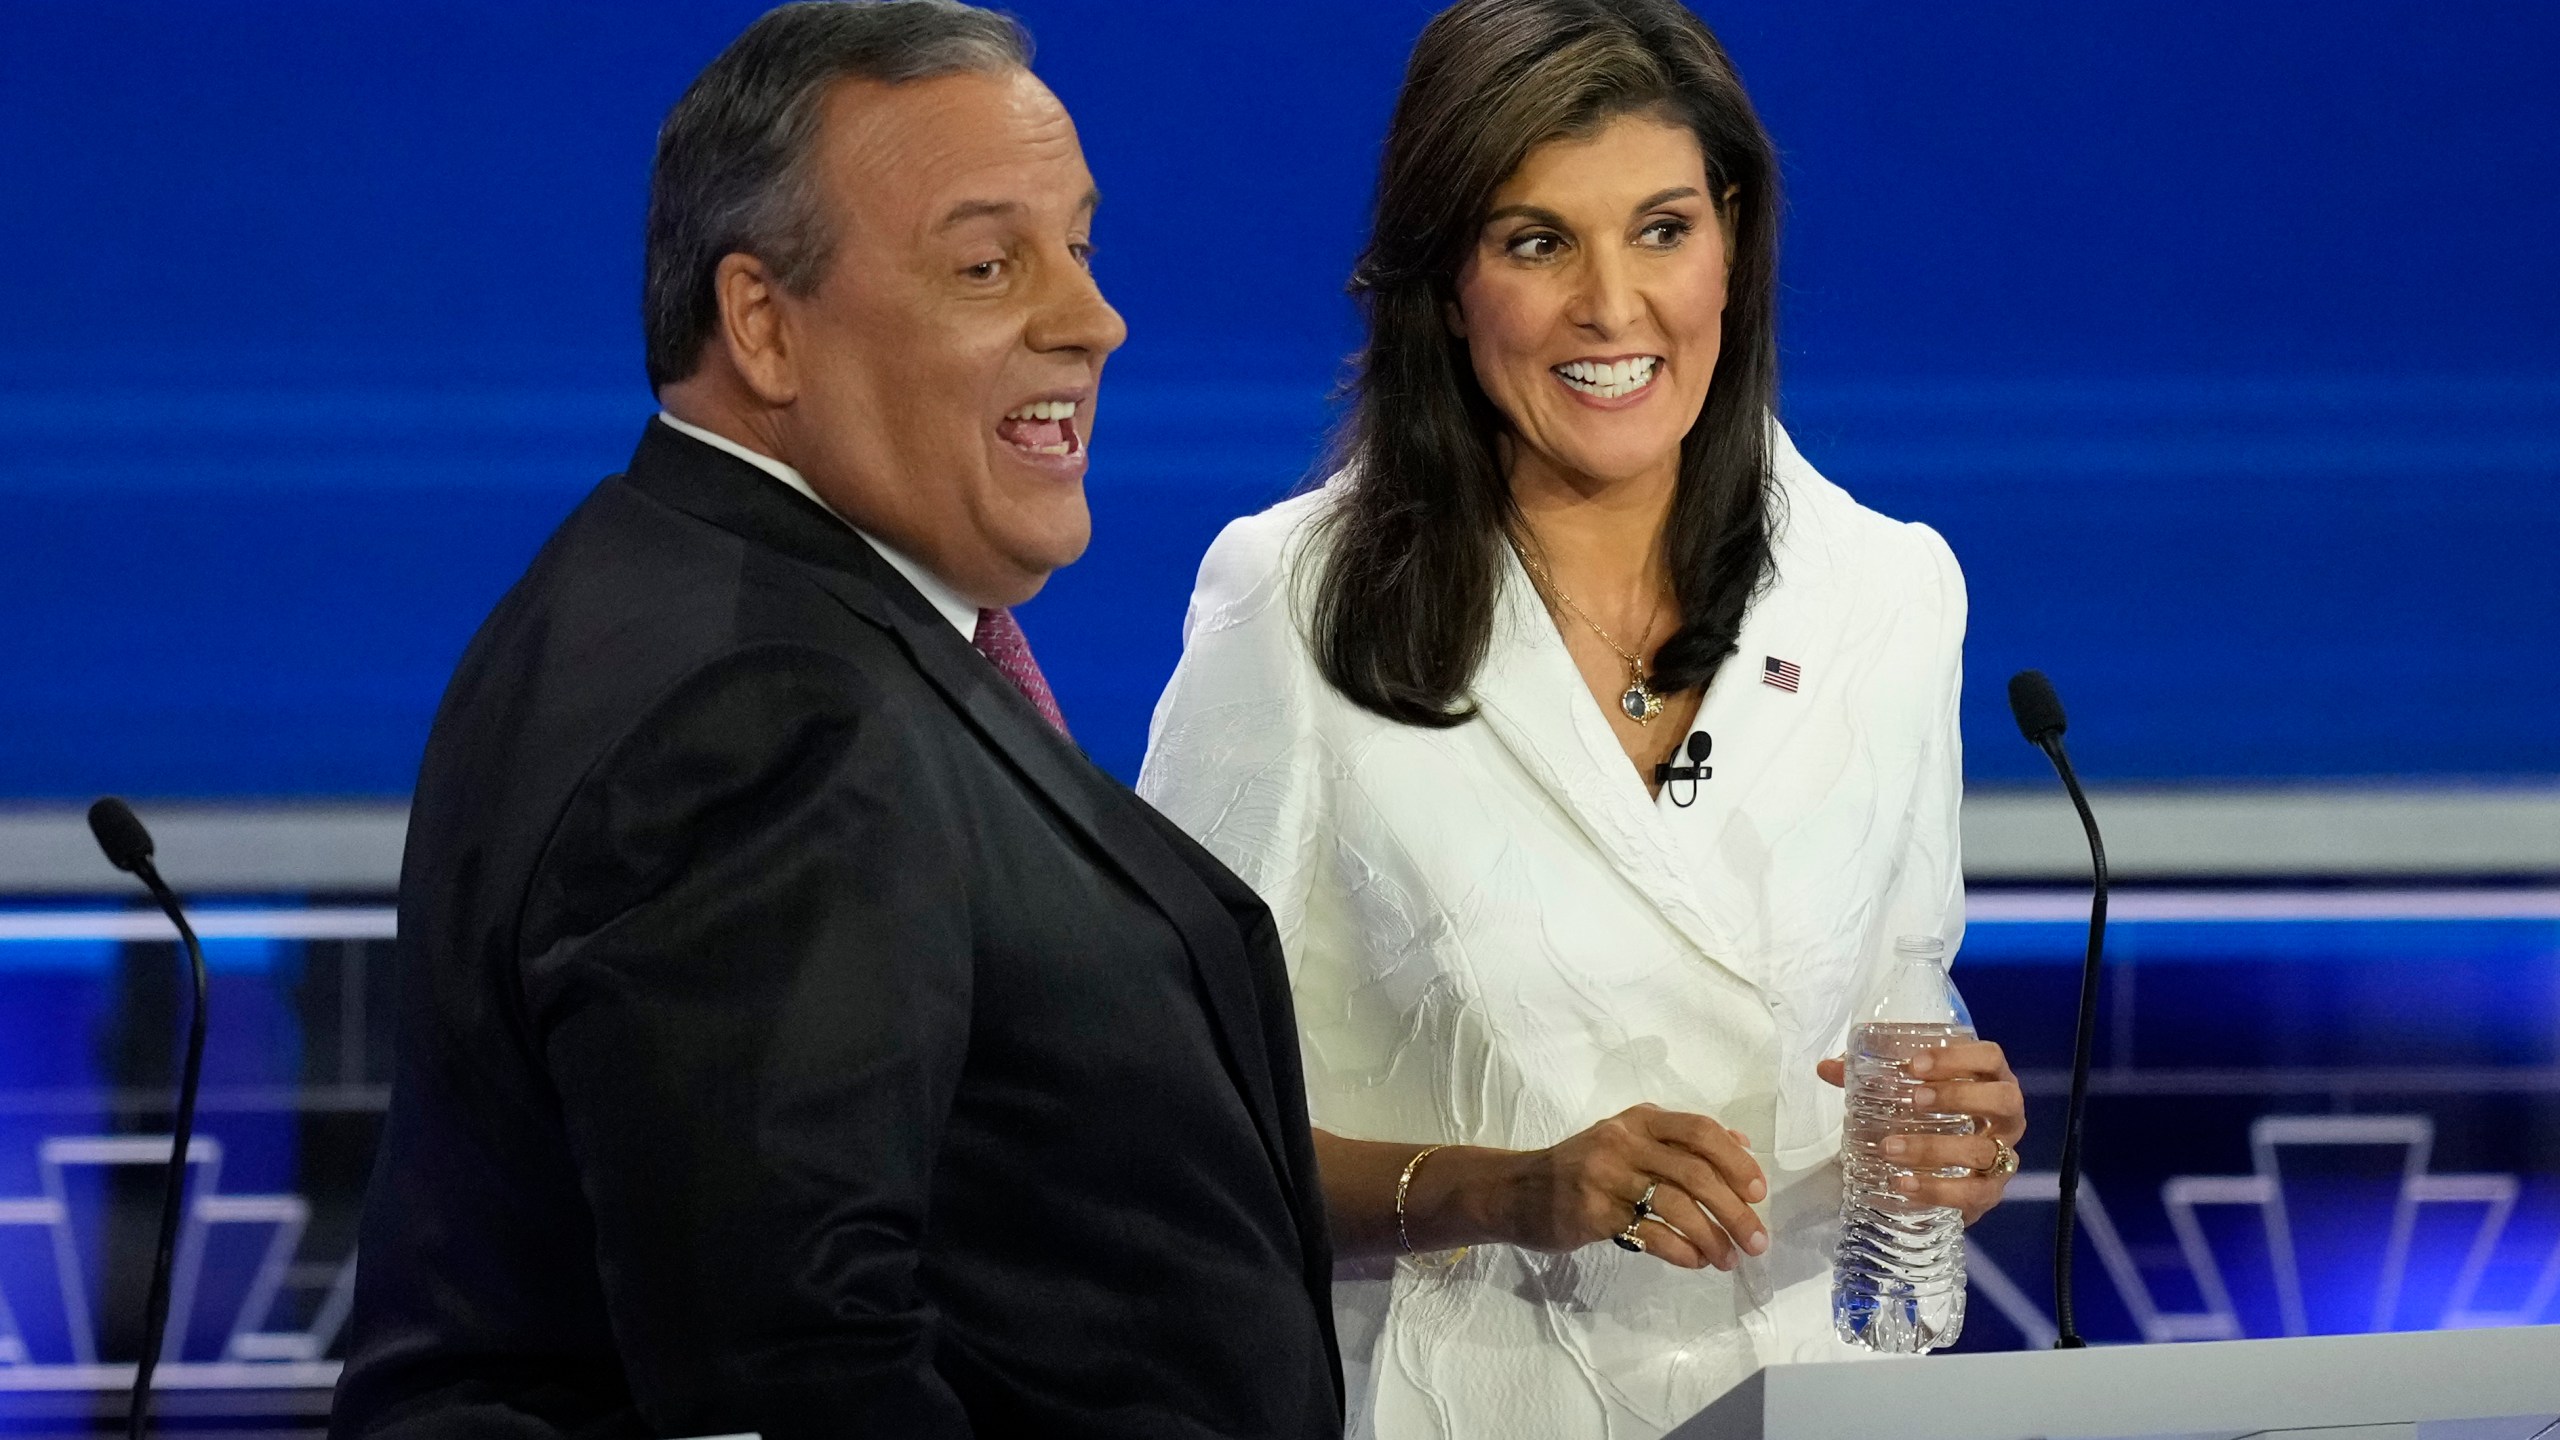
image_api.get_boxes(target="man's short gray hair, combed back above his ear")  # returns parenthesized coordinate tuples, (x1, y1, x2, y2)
(640, 0, 1032, 389)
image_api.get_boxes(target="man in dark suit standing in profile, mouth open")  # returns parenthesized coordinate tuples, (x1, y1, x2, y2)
(333, 3, 1341, 1440)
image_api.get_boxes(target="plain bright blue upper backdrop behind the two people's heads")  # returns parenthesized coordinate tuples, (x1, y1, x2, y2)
(0, 0, 2560, 797)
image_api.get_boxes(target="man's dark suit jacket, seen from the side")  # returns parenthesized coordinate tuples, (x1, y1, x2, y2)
(333, 423, 1341, 1440)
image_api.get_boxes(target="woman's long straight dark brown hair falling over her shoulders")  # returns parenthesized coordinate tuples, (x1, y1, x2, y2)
(1308, 0, 1777, 728)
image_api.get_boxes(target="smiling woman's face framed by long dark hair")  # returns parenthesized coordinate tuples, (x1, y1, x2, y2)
(1449, 115, 1731, 484)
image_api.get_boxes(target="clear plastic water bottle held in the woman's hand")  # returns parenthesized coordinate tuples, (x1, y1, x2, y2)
(1830, 935, 1974, 1355)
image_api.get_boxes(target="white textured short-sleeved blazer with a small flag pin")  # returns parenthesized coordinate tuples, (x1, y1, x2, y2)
(1139, 430, 1966, 1440)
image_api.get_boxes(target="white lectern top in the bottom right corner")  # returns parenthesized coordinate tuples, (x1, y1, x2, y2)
(1669, 1325, 2560, 1440)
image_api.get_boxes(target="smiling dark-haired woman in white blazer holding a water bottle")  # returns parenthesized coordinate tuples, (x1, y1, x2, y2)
(1139, 0, 2025, 1440)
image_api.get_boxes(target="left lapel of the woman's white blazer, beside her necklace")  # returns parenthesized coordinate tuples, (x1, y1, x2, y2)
(1472, 543, 1769, 986)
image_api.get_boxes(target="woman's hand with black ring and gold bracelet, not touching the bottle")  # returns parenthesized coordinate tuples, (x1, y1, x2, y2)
(1464, 1104, 1769, 1271)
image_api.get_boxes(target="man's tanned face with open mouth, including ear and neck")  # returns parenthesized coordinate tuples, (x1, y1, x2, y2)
(778, 69, 1129, 605)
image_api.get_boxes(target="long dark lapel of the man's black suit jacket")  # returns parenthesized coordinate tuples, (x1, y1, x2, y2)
(625, 423, 1321, 1209)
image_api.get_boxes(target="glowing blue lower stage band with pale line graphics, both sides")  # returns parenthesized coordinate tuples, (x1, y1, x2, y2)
(0, 889, 2560, 1420)
